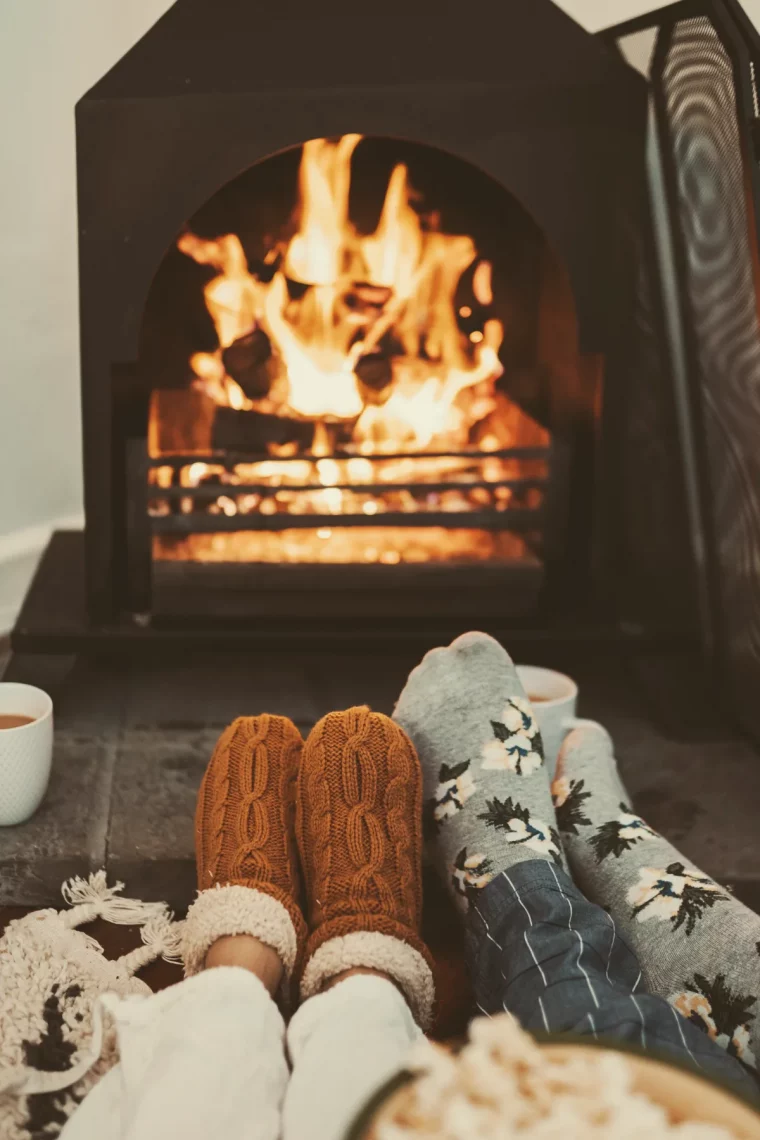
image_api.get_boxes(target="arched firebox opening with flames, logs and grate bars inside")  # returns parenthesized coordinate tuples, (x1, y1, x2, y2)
(138, 135, 558, 574)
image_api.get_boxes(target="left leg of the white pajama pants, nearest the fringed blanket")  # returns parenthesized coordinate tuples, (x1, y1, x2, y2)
(62, 968, 288, 1140)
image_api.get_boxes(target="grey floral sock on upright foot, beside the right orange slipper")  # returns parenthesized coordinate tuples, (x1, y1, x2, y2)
(393, 633, 563, 909)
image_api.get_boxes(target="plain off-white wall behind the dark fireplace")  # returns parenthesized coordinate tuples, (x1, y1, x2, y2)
(0, 0, 760, 630)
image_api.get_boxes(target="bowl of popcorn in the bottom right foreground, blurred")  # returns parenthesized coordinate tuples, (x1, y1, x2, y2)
(349, 1015, 760, 1140)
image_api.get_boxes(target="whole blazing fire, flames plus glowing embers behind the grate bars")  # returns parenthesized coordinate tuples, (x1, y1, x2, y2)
(153, 135, 548, 563)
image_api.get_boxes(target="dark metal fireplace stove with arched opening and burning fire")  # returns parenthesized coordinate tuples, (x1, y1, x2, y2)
(16, 0, 724, 645)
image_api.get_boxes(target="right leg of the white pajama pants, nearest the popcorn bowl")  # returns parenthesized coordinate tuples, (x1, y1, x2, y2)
(283, 975, 422, 1140)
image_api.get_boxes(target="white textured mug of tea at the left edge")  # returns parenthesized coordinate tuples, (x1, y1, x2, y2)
(0, 681, 52, 828)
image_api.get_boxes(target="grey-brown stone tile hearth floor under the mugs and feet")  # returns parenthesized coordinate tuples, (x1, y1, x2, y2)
(0, 650, 760, 909)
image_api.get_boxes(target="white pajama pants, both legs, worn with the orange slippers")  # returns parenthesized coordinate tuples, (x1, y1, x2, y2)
(62, 968, 420, 1140)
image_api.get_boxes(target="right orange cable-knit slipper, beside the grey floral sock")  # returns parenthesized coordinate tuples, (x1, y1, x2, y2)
(296, 708, 434, 1028)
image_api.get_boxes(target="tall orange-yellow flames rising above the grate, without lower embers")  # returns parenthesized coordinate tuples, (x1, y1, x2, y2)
(178, 135, 502, 433)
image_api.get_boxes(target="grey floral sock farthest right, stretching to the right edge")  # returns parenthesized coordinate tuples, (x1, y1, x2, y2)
(551, 726, 760, 1068)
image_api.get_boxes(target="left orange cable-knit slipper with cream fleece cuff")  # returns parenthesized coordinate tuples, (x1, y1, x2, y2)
(182, 714, 307, 982)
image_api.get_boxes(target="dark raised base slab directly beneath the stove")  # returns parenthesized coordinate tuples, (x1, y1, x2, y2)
(11, 531, 673, 661)
